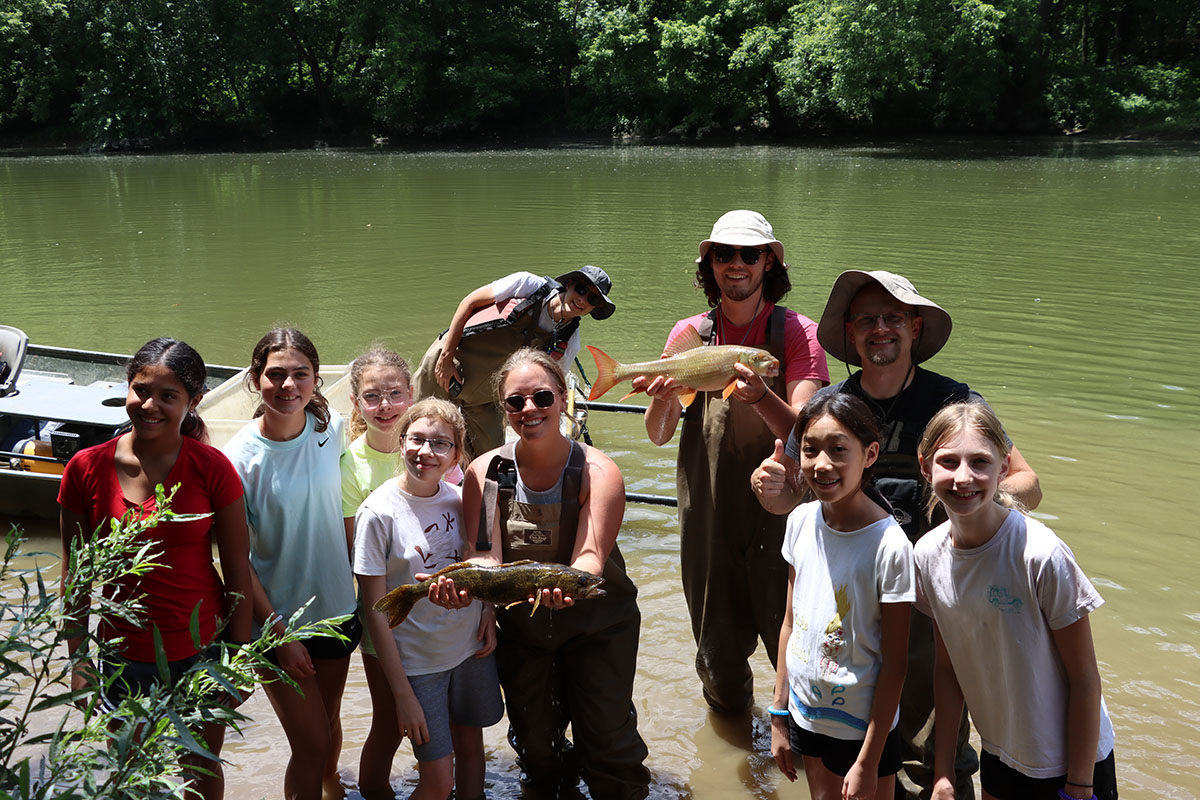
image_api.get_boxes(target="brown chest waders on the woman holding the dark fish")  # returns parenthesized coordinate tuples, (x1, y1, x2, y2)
(476, 441, 650, 800)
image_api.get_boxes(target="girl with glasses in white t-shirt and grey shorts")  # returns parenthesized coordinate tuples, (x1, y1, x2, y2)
(354, 398, 504, 800)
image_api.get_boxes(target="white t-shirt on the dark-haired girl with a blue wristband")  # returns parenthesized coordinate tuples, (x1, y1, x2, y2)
(782, 503, 916, 740)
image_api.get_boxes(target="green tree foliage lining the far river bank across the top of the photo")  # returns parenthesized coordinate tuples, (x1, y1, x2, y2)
(0, 0, 1200, 146)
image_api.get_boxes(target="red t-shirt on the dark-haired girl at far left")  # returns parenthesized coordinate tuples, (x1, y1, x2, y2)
(59, 437, 242, 662)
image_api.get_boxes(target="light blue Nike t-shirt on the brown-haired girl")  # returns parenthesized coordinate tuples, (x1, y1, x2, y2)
(224, 413, 358, 636)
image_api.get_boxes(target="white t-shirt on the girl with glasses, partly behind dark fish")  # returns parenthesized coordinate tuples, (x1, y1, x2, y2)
(354, 481, 484, 675)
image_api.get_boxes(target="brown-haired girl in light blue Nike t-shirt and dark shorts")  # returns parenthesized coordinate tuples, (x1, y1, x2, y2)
(224, 327, 361, 800)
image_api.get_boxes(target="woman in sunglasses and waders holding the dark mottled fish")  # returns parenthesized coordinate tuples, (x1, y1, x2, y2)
(430, 349, 650, 800)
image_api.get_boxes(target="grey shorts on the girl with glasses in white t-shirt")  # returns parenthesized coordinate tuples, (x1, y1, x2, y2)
(408, 654, 504, 762)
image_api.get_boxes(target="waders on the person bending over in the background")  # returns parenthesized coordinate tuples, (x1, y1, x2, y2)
(413, 278, 580, 457)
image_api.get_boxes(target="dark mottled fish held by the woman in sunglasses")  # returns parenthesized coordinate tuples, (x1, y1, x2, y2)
(374, 560, 607, 627)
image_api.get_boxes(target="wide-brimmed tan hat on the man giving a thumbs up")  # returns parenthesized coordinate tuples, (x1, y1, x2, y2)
(817, 270, 952, 367)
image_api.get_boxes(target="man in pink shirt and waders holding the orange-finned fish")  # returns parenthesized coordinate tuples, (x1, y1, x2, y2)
(634, 210, 829, 714)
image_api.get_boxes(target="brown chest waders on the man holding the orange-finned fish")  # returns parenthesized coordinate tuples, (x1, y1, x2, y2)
(676, 306, 787, 714)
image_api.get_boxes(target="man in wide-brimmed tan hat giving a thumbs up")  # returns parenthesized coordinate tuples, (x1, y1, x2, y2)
(750, 270, 1042, 799)
